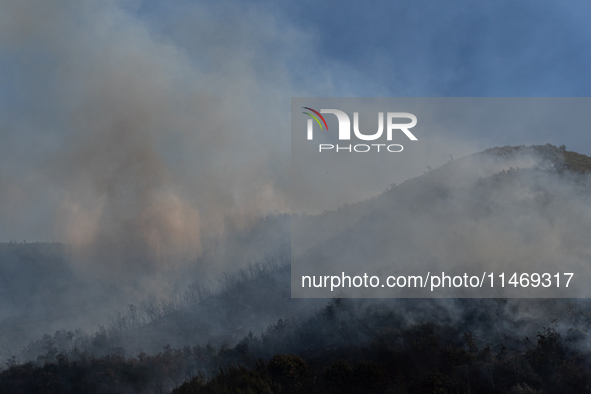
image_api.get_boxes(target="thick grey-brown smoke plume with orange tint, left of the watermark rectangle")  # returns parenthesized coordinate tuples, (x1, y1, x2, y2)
(0, 0, 306, 279)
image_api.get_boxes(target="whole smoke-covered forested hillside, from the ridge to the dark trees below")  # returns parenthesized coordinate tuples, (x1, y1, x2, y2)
(0, 145, 591, 394)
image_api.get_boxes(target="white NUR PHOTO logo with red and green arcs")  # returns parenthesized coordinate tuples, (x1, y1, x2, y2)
(302, 107, 418, 152)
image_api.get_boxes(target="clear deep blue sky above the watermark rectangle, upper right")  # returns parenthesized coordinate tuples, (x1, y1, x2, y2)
(135, 0, 591, 96)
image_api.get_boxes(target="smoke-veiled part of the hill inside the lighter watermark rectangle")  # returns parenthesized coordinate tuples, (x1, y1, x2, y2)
(292, 145, 591, 297)
